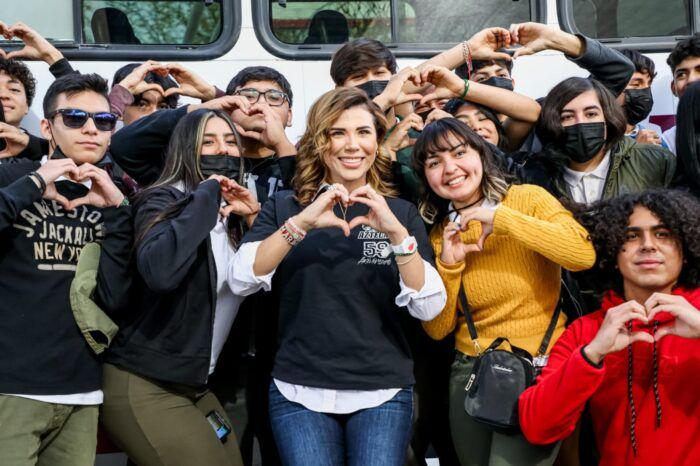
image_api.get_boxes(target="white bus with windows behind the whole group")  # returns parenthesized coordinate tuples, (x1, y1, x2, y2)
(0, 0, 688, 466)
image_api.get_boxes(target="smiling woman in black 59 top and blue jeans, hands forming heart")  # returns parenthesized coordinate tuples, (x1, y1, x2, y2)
(231, 88, 445, 466)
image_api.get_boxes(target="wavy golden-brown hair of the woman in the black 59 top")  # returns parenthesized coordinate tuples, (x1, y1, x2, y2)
(292, 87, 396, 205)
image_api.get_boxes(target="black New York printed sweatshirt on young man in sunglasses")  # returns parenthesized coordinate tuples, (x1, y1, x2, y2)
(0, 162, 133, 395)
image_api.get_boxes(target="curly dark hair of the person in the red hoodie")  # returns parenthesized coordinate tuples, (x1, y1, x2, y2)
(574, 189, 700, 294)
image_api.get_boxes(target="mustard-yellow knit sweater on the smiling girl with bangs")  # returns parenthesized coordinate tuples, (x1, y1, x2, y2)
(423, 185, 595, 356)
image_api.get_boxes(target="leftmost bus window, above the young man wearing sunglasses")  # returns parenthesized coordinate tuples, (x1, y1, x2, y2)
(0, 0, 241, 60)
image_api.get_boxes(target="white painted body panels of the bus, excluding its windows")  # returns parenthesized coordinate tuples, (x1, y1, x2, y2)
(5, 0, 677, 141)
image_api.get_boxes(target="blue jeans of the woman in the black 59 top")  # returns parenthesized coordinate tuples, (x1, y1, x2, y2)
(270, 382, 413, 466)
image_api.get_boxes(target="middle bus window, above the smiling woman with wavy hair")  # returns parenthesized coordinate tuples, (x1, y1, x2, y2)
(266, 0, 544, 56)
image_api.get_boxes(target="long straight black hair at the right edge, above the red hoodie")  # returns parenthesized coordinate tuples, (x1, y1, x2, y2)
(673, 82, 700, 197)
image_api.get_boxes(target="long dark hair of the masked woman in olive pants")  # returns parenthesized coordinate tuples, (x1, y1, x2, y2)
(135, 109, 245, 247)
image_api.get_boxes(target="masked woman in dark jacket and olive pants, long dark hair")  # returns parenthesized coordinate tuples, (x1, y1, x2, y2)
(102, 110, 259, 466)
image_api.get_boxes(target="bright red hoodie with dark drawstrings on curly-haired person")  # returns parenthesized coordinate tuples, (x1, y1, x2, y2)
(519, 288, 700, 466)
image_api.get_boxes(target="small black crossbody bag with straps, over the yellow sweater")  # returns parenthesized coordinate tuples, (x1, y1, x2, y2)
(459, 284, 562, 432)
